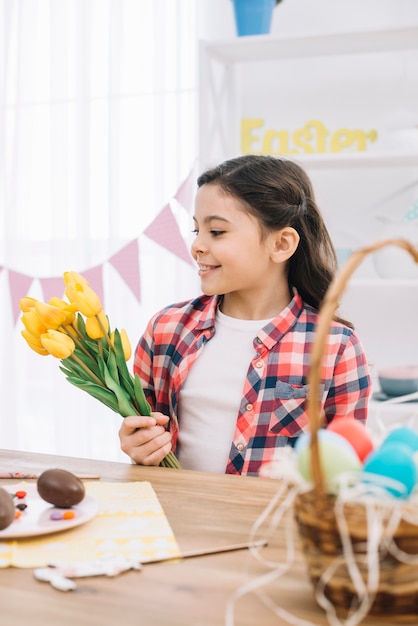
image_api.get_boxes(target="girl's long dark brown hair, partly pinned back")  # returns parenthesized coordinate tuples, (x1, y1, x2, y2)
(197, 154, 351, 326)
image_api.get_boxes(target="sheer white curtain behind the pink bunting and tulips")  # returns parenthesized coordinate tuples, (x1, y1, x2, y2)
(0, 0, 197, 458)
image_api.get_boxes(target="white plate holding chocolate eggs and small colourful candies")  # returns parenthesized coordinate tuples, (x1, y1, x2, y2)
(0, 485, 99, 540)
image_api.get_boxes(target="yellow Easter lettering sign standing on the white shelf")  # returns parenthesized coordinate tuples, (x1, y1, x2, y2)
(241, 118, 377, 155)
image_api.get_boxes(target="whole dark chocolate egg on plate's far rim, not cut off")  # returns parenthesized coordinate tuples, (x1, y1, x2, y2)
(37, 469, 86, 508)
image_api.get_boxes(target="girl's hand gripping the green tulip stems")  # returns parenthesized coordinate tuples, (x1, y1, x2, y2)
(119, 413, 171, 465)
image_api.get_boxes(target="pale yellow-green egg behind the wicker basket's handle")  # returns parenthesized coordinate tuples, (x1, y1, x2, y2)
(295, 429, 362, 482)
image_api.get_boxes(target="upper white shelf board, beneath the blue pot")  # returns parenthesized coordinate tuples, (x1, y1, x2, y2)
(201, 28, 418, 63)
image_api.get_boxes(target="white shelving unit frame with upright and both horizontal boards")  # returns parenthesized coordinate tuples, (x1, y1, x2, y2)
(199, 26, 418, 170)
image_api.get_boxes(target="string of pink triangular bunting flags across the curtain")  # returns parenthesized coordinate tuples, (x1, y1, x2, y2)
(0, 167, 194, 324)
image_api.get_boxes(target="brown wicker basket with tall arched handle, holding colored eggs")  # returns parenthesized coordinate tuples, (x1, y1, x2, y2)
(294, 239, 418, 622)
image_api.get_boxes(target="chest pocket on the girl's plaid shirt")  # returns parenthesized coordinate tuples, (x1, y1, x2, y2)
(269, 380, 308, 437)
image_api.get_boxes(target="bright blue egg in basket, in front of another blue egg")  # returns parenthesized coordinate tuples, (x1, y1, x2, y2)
(364, 442, 417, 498)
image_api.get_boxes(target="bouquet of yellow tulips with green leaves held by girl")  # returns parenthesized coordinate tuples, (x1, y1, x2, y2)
(20, 272, 180, 468)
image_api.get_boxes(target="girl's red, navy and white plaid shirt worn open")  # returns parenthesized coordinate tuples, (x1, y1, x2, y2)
(134, 293, 371, 475)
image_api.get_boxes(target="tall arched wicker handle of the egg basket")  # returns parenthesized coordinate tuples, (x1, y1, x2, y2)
(307, 239, 418, 496)
